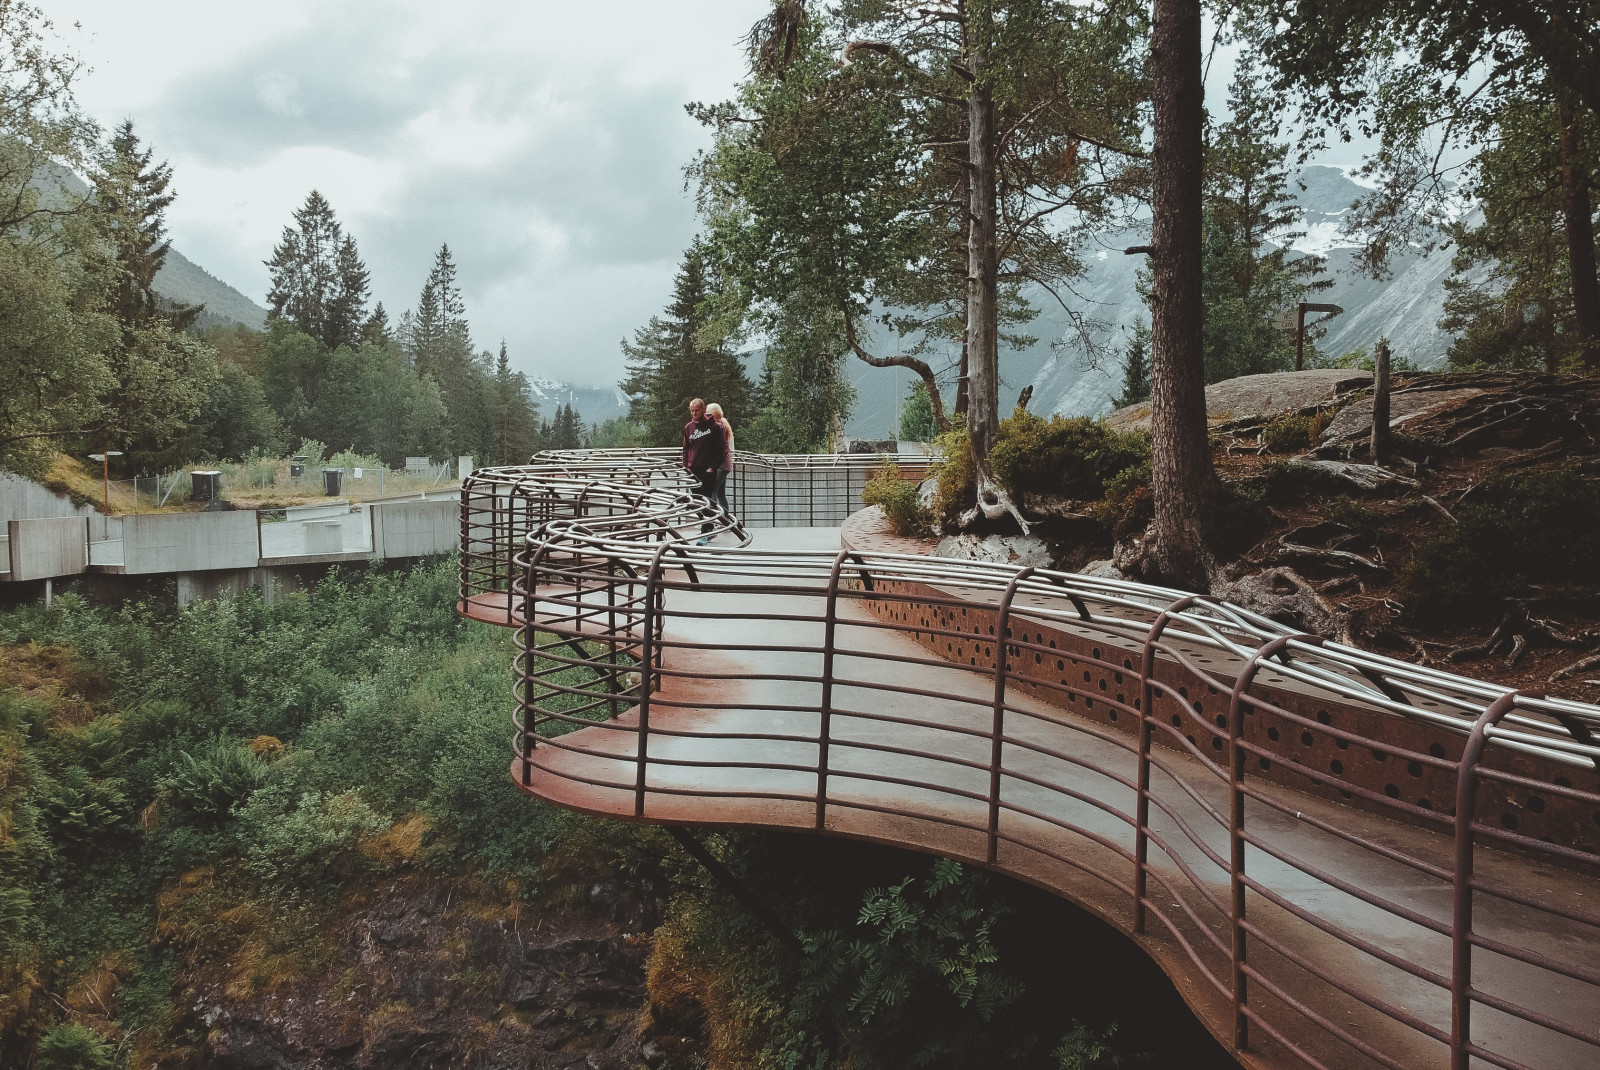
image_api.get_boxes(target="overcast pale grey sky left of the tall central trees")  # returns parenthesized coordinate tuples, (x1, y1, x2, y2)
(42, 0, 768, 385)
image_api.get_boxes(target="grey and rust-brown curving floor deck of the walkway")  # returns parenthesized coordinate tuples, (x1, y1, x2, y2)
(461, 518, 1600, 1070)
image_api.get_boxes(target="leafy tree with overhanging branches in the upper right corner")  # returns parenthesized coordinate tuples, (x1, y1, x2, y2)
(1256, 0, 1600, 369)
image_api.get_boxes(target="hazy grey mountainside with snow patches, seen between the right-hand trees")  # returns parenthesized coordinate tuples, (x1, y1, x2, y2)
(845, 166, 1451, 438)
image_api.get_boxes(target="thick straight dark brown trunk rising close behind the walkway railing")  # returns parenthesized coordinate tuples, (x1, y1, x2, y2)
(1149, 0, 1216, 590)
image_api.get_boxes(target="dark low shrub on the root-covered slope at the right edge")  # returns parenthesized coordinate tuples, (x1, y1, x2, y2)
(1402, 472, 1600, 624)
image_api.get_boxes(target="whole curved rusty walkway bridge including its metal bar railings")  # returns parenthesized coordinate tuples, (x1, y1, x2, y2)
(458, 451, 1600, 1070)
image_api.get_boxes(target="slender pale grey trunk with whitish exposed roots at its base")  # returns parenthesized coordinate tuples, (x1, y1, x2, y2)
(962, 50, 1029, 533)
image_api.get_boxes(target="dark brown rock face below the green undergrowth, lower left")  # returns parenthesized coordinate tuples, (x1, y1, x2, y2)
(180, 881, 661, 1070)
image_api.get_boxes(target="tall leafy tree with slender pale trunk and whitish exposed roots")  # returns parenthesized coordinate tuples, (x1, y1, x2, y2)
(693, 0, 1144, 517)
